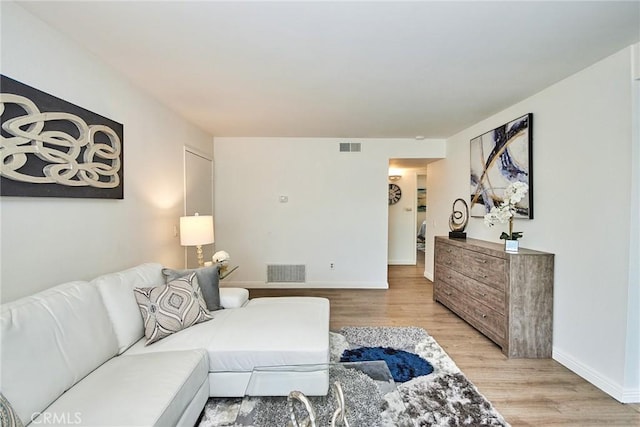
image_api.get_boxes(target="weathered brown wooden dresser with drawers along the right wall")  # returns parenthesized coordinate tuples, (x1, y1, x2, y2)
(433, 237, 554, 358)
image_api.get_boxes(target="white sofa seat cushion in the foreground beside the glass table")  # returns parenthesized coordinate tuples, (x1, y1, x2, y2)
(34, 350, 209, 426)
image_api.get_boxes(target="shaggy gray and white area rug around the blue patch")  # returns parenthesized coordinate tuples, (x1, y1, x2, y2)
(200, 327, 509, 427)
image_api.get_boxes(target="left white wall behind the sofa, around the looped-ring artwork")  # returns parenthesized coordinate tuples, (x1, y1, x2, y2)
(0, 2, 212, 302)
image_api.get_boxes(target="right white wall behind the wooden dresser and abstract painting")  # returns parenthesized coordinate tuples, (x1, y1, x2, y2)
(427, 48, 640, 401)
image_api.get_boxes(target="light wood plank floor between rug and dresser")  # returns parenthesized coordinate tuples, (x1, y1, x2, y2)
(250, 252, 640, 427)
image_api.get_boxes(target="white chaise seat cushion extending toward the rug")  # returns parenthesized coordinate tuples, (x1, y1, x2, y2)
(125, 297, 329, 372)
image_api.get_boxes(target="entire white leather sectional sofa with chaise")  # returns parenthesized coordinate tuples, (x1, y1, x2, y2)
(0, 264, 329, 426)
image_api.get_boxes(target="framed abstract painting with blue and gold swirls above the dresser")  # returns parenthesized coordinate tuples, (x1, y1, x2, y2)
(470, 113, 533, 219)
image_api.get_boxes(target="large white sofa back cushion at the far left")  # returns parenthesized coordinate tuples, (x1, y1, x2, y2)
(0, 282, 118, 424)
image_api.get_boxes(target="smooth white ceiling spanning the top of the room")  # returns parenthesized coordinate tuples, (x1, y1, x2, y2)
(20, 1, 640, 138)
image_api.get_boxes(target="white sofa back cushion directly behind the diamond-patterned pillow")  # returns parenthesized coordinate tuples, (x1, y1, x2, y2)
(91, 263, 164, 354)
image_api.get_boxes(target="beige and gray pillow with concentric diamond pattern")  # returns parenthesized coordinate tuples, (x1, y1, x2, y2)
(133, 273, 213, 345)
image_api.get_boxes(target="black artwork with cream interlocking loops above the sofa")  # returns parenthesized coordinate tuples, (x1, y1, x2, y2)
(0, 75, 124, 199)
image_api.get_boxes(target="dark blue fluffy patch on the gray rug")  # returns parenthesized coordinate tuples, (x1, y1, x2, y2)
(340, 347, 433, 383)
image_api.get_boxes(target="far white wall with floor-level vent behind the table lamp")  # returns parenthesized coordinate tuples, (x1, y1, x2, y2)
(214, 137, 445, 288)
